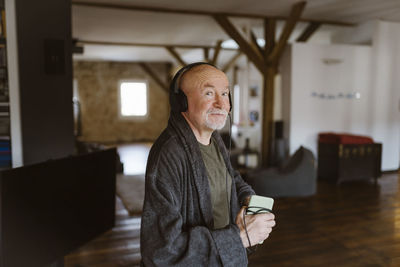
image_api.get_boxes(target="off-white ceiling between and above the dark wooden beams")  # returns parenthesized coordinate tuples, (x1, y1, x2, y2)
(72, 0, 400, 62)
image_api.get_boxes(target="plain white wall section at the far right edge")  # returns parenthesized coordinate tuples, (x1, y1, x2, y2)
(369, 22, 400, 170)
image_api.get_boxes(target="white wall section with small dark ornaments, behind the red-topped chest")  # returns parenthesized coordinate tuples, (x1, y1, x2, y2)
(289, 44, 371, 156)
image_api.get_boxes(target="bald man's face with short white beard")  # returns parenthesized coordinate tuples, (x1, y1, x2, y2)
(181, 65, 230, 136)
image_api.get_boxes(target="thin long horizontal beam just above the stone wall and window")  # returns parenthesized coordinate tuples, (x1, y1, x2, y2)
(76, 40, 238, 51)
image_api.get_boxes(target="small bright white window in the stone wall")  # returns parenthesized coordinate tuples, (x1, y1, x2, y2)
(119, 81, 148, 118)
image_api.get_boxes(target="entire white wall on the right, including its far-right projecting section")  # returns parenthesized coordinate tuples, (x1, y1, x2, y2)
(282, 22, 400, 170)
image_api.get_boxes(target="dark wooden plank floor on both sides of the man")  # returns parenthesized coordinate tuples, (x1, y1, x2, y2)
(65, 144, 400, 267)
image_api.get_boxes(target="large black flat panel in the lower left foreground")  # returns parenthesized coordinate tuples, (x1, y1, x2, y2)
(0, 149, 116, 267)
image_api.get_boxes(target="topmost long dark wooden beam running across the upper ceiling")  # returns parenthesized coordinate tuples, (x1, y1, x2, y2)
(72, 1, 356, 27)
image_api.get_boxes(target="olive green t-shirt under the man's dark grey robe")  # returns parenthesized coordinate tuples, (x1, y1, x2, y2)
(199, 138, 232, 229)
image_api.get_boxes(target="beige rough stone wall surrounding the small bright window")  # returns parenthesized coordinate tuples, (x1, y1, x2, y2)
(74, 61, 169, 143)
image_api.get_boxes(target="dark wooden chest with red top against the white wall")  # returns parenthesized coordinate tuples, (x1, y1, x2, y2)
(318, 133, 382, 184)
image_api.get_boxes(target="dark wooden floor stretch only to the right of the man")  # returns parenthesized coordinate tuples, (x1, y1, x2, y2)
(249, 174, 400, 266)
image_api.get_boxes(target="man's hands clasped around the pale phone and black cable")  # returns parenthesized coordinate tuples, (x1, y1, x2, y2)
(236, 207, 275, 248)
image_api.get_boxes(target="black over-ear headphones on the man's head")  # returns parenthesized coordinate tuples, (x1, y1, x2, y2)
(169, 62, 232, 113)
